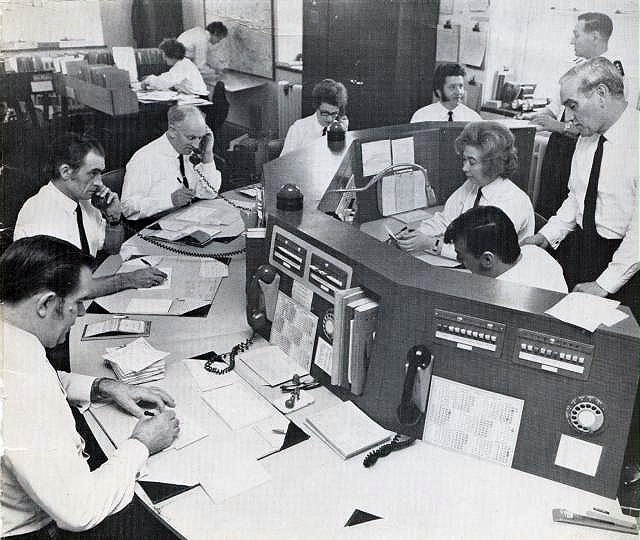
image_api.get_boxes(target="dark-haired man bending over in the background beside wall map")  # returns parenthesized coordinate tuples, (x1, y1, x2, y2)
(178, 21, 228, 88)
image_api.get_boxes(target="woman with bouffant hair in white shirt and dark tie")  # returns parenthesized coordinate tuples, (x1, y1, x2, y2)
(398, 121, 535, 259)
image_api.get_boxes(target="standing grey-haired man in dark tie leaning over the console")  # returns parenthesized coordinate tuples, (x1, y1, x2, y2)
(526, 57, 639, 317)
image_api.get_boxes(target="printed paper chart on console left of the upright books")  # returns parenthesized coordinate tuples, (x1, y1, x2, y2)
(271, 292, 318, 373)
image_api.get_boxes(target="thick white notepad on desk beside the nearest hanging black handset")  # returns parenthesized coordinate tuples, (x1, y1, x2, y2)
(305, 401, 392, 459)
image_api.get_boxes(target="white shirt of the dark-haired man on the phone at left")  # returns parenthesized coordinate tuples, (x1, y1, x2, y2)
(13, 182, 106, 257)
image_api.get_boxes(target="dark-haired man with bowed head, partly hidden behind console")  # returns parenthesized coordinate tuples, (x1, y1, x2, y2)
(444, 206, 567, 293)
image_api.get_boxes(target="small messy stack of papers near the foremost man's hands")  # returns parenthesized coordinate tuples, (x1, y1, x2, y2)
(102, 338, 169, 384)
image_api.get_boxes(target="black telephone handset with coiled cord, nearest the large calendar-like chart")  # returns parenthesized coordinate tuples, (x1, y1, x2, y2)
(362, 345, 433, 468)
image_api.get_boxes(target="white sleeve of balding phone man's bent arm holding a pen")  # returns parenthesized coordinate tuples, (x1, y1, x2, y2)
(122, 154, 172, 219)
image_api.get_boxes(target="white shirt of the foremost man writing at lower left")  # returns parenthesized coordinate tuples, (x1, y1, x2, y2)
(0, 320, 149, 537)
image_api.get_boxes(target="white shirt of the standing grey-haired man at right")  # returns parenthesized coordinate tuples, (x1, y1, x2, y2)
(540, 105, 639, 293)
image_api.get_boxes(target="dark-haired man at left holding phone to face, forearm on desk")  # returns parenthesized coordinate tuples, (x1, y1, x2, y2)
(13, 133, 167, 298)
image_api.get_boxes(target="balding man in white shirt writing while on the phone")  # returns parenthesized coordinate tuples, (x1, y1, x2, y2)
(122, 105, 222, 220)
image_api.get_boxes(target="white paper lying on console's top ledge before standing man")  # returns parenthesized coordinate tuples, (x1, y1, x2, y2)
(545, 292, 620, 332)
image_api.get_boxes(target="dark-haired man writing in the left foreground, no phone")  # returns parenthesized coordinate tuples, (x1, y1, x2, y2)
(0, 236, 180, 539)
